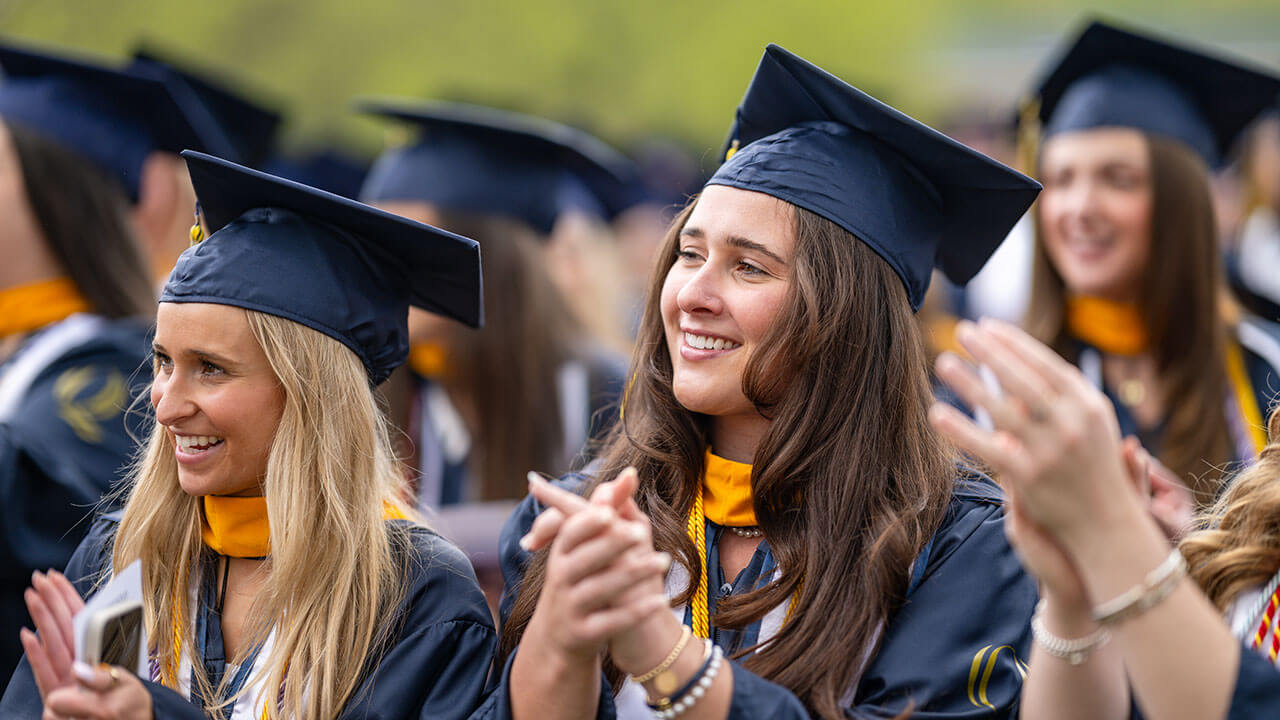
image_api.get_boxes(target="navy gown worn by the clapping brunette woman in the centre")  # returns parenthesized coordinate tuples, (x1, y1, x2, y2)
(475, 478, 1037, 720)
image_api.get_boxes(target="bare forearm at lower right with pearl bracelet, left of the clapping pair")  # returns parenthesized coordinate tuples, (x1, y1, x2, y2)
(1021, 596, 1129, 720)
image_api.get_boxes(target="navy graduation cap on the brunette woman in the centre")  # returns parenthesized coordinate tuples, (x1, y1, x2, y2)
(708, 45, 1041, 310)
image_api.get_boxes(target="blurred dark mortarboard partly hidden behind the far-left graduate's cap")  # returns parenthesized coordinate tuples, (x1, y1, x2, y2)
(129, 49, 280, 168)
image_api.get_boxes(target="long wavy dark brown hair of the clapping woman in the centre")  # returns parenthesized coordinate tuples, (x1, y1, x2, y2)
(500, 197, 954, 719)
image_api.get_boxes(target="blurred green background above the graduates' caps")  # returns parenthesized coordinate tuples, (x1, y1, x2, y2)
(0, 0, 1280, 163)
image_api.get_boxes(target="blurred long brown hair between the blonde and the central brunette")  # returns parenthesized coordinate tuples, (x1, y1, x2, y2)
(439, 210, 580, 500)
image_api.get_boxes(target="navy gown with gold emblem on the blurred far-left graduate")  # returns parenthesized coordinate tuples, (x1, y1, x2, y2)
(0, 314, 151, 676)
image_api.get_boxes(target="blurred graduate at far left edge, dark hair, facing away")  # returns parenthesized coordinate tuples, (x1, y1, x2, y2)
(0, 39, 230, 676)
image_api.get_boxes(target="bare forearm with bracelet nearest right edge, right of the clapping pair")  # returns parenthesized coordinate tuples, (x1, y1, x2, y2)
(1076, 511, 1239, 720)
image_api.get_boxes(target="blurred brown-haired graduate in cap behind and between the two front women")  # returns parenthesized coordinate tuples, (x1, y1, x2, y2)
(358, 100, 625, 504)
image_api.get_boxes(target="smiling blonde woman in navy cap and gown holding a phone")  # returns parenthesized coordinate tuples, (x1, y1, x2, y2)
(0, 148, 494, 719)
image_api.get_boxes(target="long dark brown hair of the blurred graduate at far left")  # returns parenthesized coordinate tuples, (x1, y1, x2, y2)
(5, 124, 156, 318)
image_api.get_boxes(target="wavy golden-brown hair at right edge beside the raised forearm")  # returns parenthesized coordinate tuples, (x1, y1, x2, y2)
(1180, 411, 1280, 611)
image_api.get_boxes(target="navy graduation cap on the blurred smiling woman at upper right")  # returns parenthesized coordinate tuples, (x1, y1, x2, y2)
(1036, 20, 1280, 168)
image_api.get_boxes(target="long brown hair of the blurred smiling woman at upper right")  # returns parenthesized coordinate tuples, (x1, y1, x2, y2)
(1025, 136, 1233, 502)
